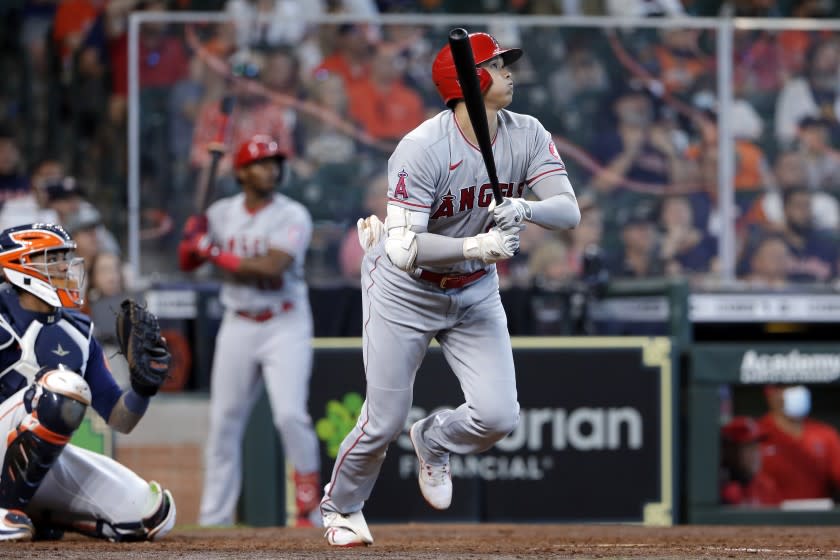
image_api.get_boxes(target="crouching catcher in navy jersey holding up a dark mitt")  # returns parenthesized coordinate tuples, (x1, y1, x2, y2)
(0, 224, 175, 541)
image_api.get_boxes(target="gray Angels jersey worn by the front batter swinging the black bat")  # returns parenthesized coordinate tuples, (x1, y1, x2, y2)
(388, 110, 566, 252)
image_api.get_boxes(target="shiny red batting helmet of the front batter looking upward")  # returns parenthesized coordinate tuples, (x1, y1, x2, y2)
(432, 33, 522, 107)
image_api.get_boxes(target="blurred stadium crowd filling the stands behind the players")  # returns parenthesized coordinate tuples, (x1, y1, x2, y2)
(0, 0, 840, 306)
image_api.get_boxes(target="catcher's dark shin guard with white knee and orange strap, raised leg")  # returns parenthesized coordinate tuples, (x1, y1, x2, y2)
(0, 368, 91, 509)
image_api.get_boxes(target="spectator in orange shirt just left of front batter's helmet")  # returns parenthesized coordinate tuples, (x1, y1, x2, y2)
(347, 44, 425, 141)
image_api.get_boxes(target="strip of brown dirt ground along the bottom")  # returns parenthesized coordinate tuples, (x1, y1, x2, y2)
(0, 523, 840, 560)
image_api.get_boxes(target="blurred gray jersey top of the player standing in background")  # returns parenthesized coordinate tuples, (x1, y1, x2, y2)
(207, 193, 312, 311)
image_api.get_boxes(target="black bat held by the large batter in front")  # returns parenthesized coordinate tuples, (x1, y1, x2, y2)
(449, 27, 504, 204)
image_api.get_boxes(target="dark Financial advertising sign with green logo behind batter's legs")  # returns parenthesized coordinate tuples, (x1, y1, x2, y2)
(310, 337, 675, 524)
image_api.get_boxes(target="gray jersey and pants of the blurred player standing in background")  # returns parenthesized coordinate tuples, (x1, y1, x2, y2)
(199, 194, 320, 525)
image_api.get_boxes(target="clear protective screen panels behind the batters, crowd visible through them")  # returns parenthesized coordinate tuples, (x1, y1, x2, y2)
(124, 17, 840, 284)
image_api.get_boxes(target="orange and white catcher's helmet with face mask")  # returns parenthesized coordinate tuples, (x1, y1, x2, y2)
(0, 224, 85, 307)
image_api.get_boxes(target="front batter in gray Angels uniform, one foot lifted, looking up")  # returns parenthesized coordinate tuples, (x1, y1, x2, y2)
(321, 33, 580, 546)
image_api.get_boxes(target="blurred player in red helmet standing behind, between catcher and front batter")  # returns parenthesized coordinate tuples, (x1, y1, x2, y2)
(179, 135, 321, 525)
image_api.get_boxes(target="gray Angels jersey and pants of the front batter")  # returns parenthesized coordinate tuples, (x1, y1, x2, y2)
(321, 107, 566, 513)
